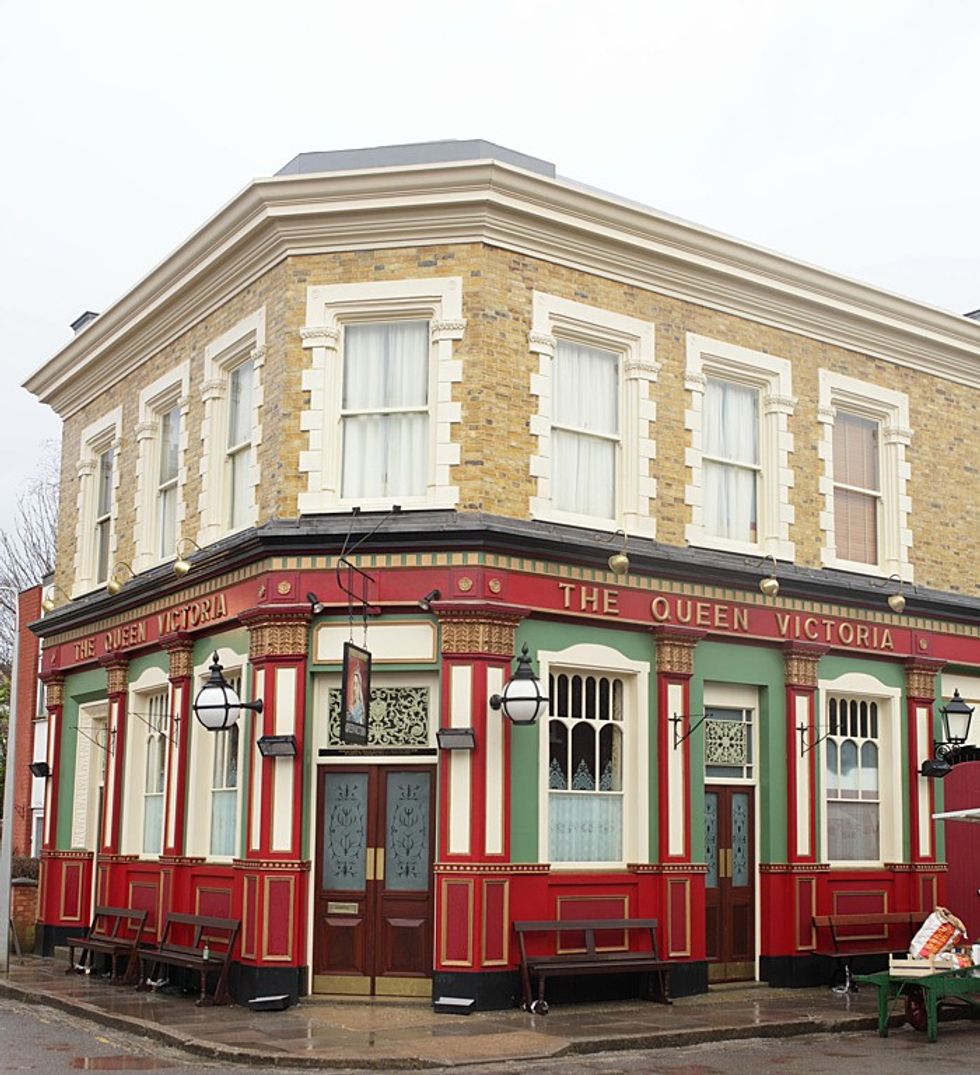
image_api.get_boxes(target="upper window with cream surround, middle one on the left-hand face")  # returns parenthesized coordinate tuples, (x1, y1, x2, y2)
(132, 362, 189, 572)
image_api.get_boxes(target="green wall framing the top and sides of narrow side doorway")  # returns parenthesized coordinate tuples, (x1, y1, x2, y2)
(691, 642, 787, 862)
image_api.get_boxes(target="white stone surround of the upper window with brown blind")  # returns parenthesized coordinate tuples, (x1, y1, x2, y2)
(817, 370, 913, 583)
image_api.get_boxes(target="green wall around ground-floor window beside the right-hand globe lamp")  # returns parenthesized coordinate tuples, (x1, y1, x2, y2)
(510, 620, 657, 862)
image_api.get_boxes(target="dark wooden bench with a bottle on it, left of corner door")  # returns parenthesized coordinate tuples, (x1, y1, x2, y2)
(140, 913, 241, 1004)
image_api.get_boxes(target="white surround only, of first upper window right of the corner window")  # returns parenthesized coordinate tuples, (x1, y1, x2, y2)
(528, 291, 660, 538)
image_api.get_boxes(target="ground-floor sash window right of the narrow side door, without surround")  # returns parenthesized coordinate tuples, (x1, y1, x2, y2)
(824, 697, 881, 862)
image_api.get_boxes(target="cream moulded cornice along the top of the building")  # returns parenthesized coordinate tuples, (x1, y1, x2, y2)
(25, 161, 980, 417)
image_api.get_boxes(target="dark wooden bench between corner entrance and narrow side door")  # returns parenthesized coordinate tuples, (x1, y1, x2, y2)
(514, 918, 671, 1015)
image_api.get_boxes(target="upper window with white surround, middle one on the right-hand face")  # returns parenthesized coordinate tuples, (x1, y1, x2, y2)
(684, 333, 796, 560)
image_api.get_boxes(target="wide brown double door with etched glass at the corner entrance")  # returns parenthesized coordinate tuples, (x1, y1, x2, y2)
(313, 764, 435, 995)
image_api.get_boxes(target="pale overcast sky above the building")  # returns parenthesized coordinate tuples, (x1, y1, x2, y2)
(0, 0, 980, 546)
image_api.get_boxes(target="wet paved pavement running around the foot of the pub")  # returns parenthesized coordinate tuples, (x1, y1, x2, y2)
(0, 956, 962, 1069)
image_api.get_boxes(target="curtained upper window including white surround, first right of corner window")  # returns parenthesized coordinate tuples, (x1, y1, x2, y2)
(529, 291, 660, 536)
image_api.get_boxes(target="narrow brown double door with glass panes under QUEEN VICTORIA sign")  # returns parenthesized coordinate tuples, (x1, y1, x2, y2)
(705, 785, 755, 981)
